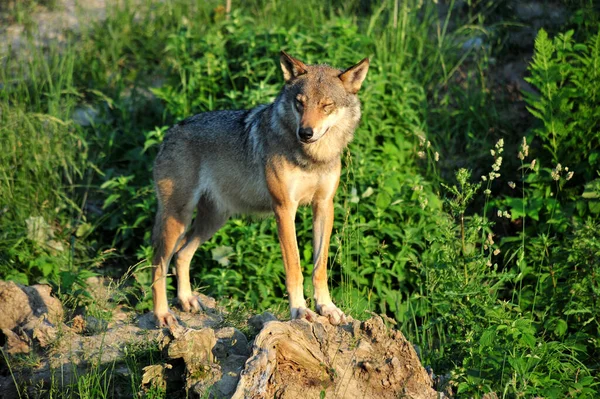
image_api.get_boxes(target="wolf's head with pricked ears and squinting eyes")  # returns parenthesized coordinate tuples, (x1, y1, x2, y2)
(280, 51, 369, 147)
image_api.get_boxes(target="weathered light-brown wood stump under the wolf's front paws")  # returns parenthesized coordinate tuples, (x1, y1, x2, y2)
(233, 316, 438, 399)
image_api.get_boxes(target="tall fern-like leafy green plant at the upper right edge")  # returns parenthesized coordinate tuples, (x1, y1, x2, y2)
(526, 29, 600, 178)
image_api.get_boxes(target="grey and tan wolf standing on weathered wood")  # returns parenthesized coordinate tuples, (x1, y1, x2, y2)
(152, 51, 369, 326)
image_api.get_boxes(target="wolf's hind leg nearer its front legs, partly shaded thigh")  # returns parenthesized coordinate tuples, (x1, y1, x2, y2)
(175, 197, 229, 312)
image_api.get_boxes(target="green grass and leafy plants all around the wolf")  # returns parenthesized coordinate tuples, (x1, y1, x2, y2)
(0, 0, 600, 398)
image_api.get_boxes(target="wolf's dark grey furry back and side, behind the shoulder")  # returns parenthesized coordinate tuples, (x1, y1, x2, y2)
(154, 109, 271, 214)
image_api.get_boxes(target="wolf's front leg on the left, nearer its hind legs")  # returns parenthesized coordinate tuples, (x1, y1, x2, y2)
(273, 204, 317, 321)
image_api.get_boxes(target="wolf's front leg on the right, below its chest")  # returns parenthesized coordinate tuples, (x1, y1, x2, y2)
(312, 198, 346, 325)
